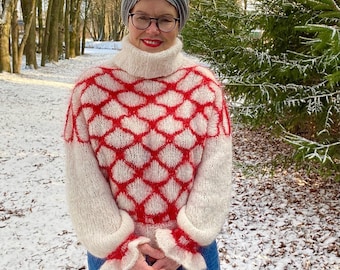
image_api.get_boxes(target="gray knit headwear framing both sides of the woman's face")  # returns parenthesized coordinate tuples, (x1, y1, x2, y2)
(121, 0, 189, 30)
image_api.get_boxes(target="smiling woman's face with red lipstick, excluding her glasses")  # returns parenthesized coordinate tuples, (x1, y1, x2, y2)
(128, 0, 179, 53)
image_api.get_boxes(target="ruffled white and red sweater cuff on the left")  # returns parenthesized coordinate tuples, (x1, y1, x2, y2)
(100, 234, 150, 270)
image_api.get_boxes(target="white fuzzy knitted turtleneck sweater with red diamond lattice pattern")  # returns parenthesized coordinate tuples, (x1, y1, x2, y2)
(64, 37, 232, 270)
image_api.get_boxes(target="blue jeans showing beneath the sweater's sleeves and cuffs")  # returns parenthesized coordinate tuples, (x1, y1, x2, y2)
(87, 241, 220, 270)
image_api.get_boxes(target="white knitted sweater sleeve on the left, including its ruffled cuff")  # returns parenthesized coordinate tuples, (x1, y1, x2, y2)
(64, 80, 149, 270)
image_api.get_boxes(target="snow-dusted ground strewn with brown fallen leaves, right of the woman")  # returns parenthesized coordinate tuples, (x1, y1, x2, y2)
(218, 126, 340, 270)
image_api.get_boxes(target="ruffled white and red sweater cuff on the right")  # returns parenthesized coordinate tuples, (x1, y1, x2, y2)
(156, 228, 207, 270)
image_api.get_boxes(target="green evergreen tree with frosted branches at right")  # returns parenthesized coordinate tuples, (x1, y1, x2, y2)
(183, 0, 340, 169)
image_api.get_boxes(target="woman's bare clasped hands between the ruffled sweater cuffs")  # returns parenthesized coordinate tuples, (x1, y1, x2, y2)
(131, 244, 180, 270)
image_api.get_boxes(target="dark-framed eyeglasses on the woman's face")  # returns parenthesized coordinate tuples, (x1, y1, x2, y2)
(129, 13, 179, 33)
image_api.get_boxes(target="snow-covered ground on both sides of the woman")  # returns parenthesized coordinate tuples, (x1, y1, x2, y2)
(0, 42, 340, 270)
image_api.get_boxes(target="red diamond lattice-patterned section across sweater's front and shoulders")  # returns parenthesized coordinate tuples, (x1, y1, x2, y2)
(65, 67, 229, 224)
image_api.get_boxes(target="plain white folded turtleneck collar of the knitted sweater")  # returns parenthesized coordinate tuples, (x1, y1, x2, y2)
(113, 36, 185, 79)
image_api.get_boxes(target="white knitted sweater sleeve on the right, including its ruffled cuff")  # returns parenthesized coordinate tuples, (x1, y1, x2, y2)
(156, 75, 232, 270)
